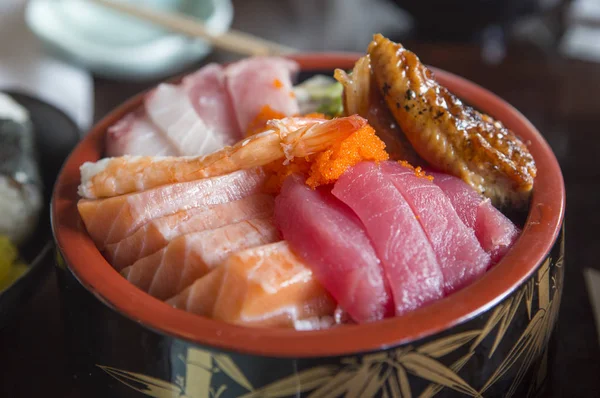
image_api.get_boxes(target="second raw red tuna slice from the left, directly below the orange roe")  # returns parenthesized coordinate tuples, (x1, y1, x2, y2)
(330, 162, 444, 315)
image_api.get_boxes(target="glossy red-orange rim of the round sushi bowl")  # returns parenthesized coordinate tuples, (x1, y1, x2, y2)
(52, 53, 565, 357)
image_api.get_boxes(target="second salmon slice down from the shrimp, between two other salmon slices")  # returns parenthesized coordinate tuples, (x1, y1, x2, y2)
(104, 194, 274, 271)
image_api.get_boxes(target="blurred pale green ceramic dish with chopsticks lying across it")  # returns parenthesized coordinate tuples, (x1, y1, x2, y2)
(26, 0, 233, 80)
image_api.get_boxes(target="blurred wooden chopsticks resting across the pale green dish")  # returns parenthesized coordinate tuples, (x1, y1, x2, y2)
(87, 0, 296, 55)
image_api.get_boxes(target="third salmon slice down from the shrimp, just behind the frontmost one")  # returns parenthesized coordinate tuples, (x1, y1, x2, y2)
(121, 218, 280, 300)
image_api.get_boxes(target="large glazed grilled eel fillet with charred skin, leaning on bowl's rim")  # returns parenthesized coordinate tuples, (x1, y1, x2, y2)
(368, 34, 537, 208)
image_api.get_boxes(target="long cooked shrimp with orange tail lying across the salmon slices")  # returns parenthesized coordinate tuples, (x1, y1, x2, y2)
(79, 115, 367, 199)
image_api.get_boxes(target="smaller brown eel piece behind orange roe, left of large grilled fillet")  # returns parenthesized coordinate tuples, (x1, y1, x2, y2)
(334, 55, 424, 166)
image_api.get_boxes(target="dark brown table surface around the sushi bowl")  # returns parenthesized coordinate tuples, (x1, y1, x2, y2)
(0, 45, 600, 398)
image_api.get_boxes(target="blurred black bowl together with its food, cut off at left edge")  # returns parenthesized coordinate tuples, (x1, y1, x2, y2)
(0, 90, 80, 328)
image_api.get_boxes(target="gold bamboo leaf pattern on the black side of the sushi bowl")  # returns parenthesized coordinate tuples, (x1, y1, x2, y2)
(97, 240, 564, 398)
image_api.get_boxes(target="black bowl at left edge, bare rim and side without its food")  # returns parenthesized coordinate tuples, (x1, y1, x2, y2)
(0, 90, 80, 328)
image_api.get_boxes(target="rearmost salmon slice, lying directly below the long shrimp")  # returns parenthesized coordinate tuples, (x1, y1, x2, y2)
(77, 169, 266, 250)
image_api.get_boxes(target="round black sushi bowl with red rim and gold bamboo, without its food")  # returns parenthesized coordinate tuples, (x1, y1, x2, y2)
(52, 54, 565, 398)
